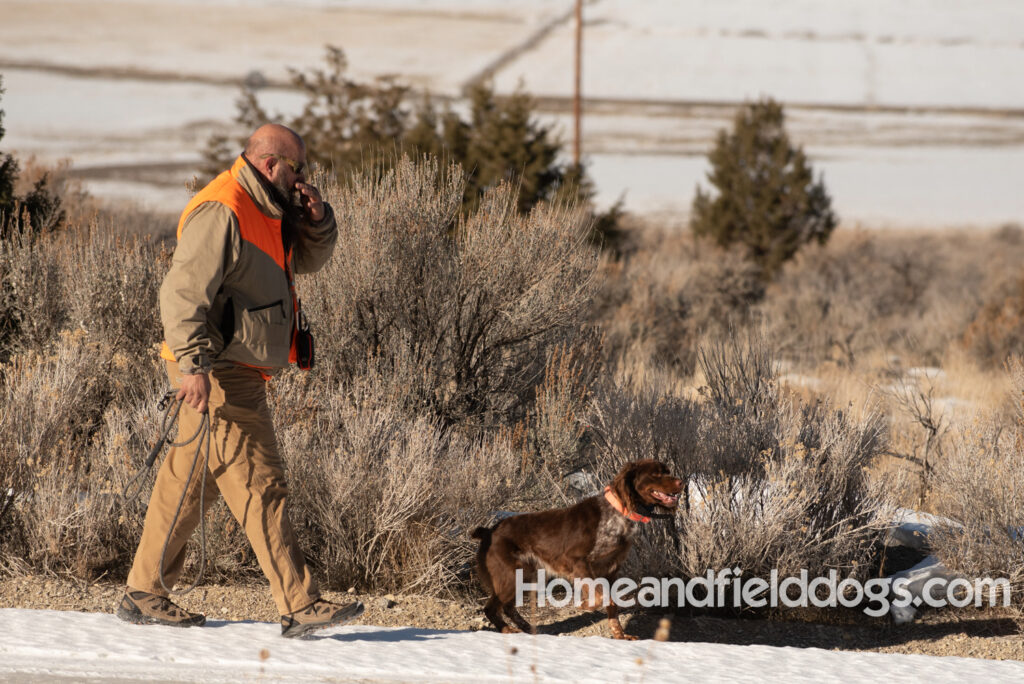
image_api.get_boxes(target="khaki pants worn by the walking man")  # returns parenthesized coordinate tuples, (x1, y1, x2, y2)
(128, 361, 319, 614)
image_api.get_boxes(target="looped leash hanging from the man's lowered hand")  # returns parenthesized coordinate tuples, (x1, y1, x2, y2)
(121, 389, 210, 596)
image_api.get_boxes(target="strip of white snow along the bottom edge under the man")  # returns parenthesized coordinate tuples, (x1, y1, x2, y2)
(0, 609, 1024, 684)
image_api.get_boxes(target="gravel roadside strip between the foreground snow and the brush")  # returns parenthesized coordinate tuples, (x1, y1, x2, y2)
(0, 576, 1024, 660)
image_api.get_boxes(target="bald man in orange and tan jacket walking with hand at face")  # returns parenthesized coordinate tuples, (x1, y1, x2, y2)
(117, 124, 362, 637)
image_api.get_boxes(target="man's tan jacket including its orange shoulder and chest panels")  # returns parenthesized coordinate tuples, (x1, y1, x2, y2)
(160, 157, 338, 374)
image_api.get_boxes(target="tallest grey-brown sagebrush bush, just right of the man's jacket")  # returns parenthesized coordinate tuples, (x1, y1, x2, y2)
(299, 159, 597, 426)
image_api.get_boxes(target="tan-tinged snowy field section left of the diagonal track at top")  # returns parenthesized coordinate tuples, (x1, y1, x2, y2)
(0, 0, 544, 90)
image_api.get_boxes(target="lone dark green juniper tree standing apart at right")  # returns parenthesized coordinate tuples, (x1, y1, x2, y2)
(690, 99, 838, 280)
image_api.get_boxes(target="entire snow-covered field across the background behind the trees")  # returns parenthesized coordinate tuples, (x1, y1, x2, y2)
(0, 0, 1024, 227)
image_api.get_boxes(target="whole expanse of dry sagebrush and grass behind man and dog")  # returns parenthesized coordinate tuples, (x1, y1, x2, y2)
(0, 160, 1024, 614)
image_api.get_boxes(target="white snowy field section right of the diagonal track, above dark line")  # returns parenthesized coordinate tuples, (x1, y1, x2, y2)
(489, 0, 1024, 108)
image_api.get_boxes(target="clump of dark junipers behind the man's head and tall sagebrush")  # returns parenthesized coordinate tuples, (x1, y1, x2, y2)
(197, 47, 621, 246)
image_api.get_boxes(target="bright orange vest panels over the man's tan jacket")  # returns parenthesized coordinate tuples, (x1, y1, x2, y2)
(160, 156, 299, 379)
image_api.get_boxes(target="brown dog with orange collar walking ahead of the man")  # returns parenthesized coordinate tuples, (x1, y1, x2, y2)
(472, 460, 683, 639)
